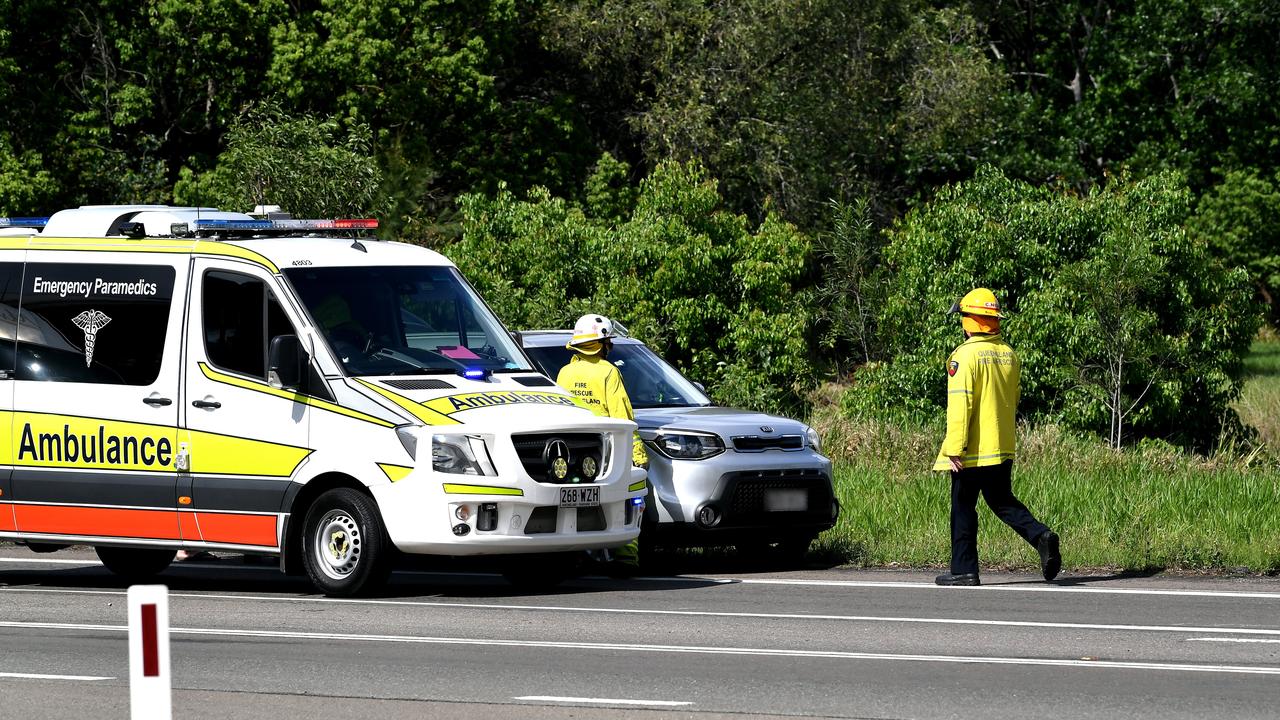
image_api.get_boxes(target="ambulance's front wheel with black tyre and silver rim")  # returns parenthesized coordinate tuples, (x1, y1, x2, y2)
(302, 488, 392, 597)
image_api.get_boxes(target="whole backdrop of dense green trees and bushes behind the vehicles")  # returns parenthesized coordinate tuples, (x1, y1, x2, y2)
(0, 0, 1280, 443)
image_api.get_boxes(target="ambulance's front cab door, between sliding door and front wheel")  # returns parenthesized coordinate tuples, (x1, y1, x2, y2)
(180, 258, 311, 550)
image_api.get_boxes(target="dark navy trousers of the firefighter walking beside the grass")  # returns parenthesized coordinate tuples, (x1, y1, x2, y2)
(951, 460, 1048, 575)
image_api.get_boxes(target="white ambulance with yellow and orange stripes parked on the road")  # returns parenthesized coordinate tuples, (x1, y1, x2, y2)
(0, 205, 645, 596)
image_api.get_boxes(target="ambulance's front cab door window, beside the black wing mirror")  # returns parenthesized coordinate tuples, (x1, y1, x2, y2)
(201, 270, 304, 380)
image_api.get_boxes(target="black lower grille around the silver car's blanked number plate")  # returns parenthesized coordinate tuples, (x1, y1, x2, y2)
(722, 469, 832, 527)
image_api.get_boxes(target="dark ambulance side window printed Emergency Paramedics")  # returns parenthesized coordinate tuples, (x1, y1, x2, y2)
(15, 263, 175, 386)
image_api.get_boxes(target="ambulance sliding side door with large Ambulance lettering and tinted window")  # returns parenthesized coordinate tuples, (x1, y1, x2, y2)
(9, 246, 191, 544)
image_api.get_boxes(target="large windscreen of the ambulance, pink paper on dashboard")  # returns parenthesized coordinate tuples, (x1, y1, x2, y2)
(284, 266, 531, 375)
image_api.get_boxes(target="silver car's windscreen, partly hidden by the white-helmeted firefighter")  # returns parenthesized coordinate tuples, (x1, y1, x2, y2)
(525, 342, 712, 409)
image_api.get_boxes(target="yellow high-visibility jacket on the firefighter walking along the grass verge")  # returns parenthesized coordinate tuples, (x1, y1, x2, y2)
(933, 334, 1021, 470)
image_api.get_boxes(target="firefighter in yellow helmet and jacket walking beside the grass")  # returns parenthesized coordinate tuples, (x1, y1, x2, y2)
(933, 287, 1062, 585)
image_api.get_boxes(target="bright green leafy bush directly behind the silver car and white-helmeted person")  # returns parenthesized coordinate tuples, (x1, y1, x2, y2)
(445, 158, 814, 410)
